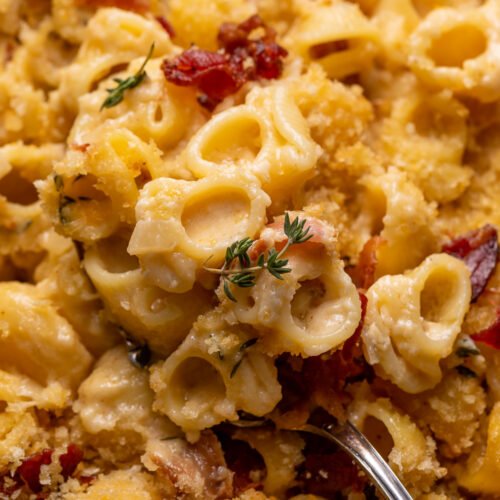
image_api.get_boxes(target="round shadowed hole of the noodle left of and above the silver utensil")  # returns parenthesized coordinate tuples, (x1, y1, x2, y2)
(169, 357, 226, 408)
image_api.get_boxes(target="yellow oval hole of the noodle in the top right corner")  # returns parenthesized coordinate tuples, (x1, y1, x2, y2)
(427, 24, 488, 68)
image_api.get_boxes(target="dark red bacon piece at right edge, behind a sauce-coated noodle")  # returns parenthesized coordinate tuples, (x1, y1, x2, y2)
(442, 224, 498, 302)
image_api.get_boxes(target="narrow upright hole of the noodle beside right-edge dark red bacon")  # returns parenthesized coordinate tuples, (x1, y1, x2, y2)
(420, 268, 459, 323)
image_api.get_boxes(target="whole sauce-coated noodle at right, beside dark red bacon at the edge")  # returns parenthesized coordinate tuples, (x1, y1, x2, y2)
(362, 254, 470, 393)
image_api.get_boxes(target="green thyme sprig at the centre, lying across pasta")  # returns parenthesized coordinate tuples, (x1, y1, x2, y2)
(204, 213, 313, 302)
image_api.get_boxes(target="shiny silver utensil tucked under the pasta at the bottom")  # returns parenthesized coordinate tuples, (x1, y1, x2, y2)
(229, 420, 412, 500)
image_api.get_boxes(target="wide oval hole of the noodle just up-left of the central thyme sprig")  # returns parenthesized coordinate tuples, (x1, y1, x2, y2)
(181, 188, 250, 246)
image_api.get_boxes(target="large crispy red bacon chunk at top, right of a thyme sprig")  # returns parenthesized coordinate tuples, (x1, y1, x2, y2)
(161, 15, 287, 109)
